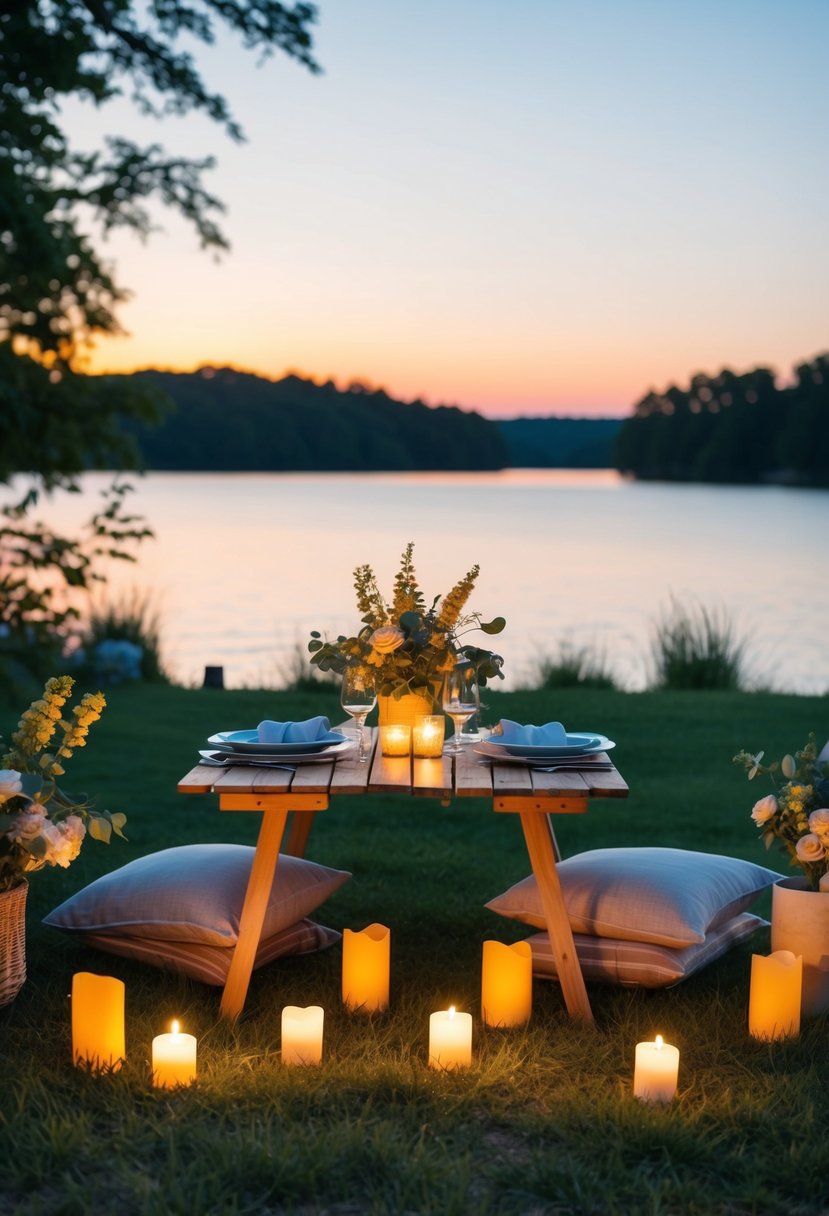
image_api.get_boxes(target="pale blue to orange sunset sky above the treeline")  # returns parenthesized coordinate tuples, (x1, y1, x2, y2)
(71, 0, 829, 416)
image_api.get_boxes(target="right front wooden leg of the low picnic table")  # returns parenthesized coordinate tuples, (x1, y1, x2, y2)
(520, 811, 593, 1025)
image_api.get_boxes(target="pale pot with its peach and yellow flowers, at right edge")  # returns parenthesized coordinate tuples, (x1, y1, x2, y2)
(734, 734, 829, 1014)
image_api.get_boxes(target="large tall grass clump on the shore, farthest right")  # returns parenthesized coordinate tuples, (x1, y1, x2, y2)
(652, 599, 746, 691)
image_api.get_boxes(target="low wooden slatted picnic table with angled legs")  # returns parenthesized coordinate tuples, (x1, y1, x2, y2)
(177, 728, 627, 1024)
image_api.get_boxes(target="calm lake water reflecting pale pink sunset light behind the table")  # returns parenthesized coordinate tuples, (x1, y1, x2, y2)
(19, 469, 829, 693)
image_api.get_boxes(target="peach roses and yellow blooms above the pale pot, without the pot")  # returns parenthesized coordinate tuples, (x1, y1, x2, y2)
(734, 734, 829, 890)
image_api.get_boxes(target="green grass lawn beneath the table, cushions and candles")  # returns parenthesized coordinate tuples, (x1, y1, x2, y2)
(0, 687, 829, 1216)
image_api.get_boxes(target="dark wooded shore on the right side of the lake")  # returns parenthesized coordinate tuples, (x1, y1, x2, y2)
(614, 353, 829, 486)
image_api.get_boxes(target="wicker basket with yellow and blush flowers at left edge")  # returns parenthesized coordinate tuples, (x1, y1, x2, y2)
(0, 676, 126, 1004)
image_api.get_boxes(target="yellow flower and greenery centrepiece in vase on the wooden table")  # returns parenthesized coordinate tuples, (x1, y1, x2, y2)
(308, 542, 506, 721)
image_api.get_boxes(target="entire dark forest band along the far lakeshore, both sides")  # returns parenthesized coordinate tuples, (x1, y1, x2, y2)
(107, 354, 829, 486)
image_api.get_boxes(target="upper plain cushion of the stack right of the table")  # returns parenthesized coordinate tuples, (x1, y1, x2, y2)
(486, 848, 780, 948)
